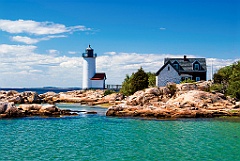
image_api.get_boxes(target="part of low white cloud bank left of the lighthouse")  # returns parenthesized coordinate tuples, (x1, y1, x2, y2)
(0, 44, 82, 87)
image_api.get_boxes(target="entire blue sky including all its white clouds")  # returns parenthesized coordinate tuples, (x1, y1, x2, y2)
(0, 0, 240, 87)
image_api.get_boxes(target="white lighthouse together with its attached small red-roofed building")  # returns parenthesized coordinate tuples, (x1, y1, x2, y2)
(82, 45, 107, 89)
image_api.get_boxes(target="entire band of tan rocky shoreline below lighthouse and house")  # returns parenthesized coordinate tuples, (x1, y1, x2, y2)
(0, 81, 240, 118)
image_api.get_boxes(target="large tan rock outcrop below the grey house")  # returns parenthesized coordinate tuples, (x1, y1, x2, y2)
(106, 81, 240, 118)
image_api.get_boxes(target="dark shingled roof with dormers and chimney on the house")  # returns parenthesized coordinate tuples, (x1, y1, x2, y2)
(164, 56, 207, 72)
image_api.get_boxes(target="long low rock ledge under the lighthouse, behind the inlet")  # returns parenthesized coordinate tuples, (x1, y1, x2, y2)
(0, 90, 124, 105)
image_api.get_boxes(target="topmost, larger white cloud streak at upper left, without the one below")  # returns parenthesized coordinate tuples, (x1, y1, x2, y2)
(0, 19, 91, 35)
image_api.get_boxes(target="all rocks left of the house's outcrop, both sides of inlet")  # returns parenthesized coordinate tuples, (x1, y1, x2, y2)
(0, 90, 123, 118)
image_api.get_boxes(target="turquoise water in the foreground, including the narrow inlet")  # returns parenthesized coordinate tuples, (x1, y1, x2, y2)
(0, 104, 240, 161)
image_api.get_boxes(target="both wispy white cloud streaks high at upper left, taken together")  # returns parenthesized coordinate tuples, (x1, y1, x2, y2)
(0, 19, 92, 44)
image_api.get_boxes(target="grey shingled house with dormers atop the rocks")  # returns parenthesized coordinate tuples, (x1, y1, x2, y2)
(156, 55, 207, 87)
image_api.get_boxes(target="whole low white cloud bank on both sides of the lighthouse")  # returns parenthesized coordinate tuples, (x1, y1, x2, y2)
(0, 44, 237, 87)
